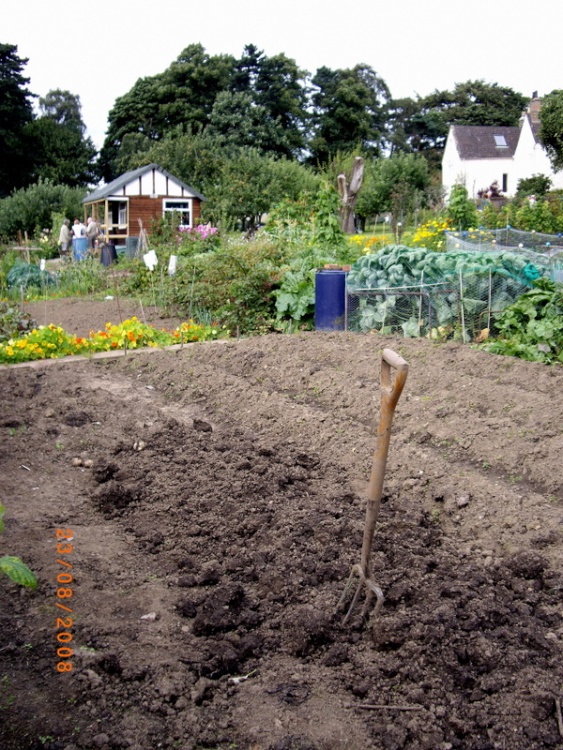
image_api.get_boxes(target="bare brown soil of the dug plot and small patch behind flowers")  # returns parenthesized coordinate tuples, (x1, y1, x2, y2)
(0, 302, 563, 750)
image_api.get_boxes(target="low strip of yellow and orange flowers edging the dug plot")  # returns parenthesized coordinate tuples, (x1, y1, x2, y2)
(0, 317, 224, 364)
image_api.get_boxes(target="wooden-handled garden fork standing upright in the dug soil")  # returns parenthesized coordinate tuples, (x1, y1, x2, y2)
(338, 349, 409, 623)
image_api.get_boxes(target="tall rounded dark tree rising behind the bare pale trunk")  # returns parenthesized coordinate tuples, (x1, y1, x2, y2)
(309, 65, 390, 163)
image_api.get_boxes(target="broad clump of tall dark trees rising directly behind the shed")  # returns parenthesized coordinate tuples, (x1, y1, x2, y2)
(100, 44, 307, 180)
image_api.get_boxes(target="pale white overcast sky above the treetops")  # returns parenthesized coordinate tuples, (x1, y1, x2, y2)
(0, 0, 563, 148)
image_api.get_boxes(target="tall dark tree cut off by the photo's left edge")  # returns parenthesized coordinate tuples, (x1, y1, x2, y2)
(0, 44, 34, 196)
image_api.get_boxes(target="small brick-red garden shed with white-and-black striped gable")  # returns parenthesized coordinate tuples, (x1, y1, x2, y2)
(82, 164, 205, 247)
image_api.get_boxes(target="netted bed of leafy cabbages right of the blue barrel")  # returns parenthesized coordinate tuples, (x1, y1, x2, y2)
(346, 245, 546, 341)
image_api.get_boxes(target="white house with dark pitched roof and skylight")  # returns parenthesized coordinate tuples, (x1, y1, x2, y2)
(442, 92, 563, 198)
